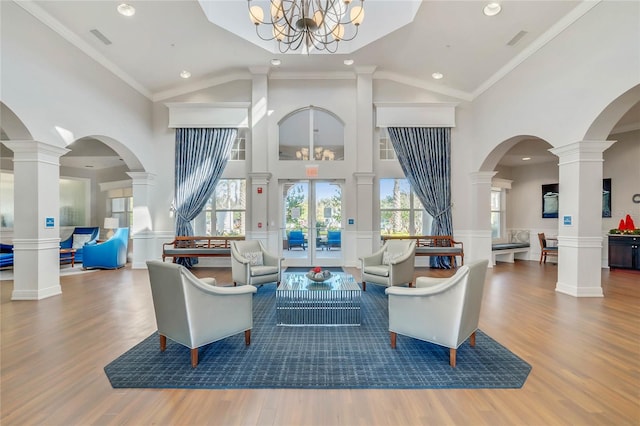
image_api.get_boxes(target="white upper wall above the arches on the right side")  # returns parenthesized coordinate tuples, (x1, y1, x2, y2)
(473, 1, 640, 163)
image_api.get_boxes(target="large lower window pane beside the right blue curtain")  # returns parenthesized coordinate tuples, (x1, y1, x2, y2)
(380, 179, 431, 235)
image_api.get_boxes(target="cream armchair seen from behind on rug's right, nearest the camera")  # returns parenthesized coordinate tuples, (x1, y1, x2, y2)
(385, 260, 489, 367)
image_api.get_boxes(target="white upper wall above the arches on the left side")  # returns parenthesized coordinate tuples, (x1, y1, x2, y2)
(0, 2, 154, 170)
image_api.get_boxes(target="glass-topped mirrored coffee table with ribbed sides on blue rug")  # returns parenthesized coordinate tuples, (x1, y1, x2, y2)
(276, 272, 361, 326)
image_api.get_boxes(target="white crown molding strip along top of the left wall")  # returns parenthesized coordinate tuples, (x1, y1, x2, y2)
(14, 0, 152, 99)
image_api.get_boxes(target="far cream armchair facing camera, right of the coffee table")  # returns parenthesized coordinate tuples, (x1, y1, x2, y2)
(360, 240, 416, 291)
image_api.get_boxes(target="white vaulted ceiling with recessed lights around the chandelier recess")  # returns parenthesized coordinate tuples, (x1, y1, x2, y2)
(7, 0, 636, 167)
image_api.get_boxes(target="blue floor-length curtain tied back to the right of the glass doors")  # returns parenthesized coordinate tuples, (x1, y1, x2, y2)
(388, 127, 455, 268)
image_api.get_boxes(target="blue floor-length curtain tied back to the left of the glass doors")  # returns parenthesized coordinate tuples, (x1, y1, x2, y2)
(174, 128, 238, 268)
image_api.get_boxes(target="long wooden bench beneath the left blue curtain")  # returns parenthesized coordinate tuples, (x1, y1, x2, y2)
(162, 235, 244, 263)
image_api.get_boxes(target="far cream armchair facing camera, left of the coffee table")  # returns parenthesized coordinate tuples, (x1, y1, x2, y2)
(231, 240, 282, 285)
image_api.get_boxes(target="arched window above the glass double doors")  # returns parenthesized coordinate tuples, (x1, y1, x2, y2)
(278, 106, 344, 161)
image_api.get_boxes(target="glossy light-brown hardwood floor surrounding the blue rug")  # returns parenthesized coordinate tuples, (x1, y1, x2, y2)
(0, 261, 640, 426)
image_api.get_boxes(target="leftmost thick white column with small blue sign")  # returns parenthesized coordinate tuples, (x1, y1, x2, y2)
(3, 141, 69, 300)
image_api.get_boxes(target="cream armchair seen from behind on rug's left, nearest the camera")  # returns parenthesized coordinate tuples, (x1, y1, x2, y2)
(147, 260, 256, 367)
